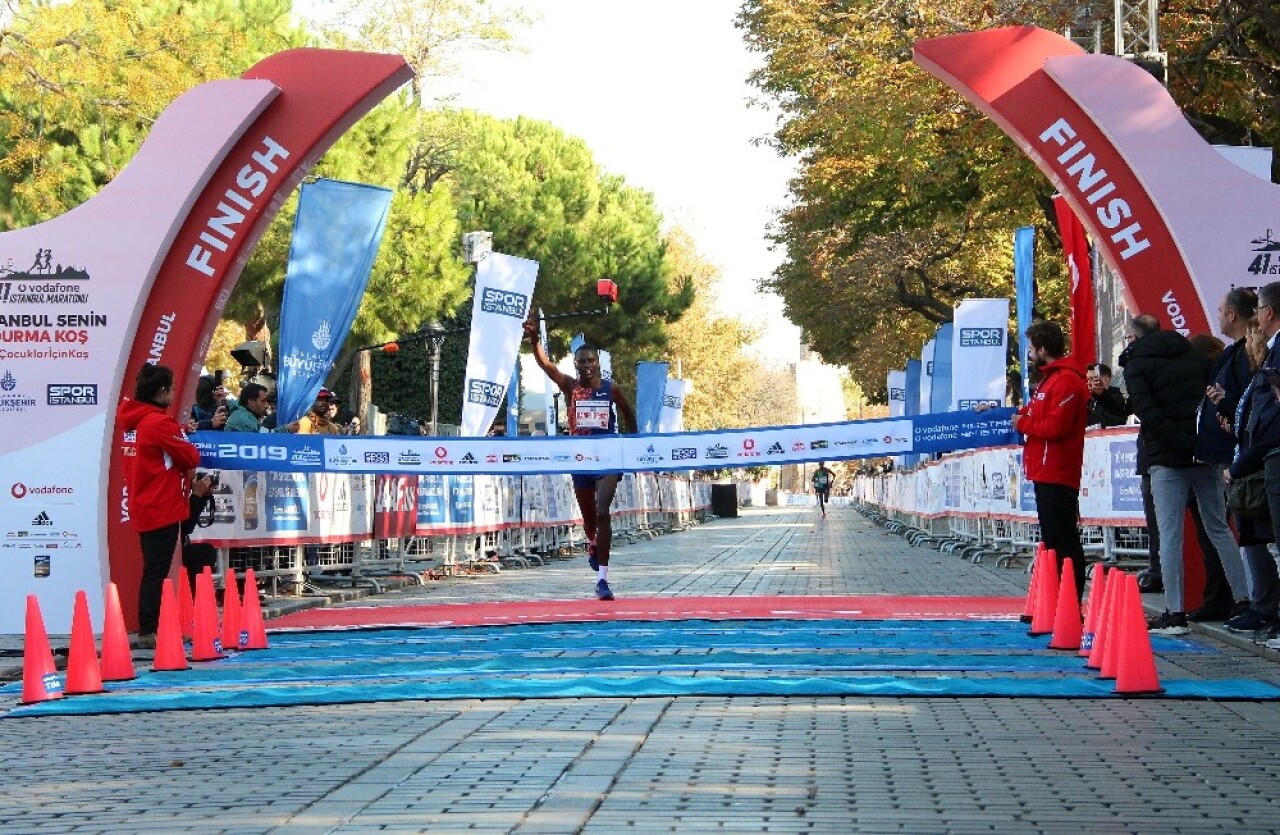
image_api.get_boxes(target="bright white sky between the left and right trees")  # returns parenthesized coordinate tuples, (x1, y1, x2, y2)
(303, 0, 799, 361)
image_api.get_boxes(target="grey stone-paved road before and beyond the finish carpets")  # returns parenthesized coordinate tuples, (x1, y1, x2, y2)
(0, 508, 1280, 835)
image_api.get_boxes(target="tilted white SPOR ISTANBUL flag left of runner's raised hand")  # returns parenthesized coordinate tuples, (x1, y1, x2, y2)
(461, 252, 538, 438)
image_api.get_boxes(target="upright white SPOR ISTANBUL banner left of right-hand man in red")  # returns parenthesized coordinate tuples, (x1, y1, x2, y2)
(951, 298, 1009, 410)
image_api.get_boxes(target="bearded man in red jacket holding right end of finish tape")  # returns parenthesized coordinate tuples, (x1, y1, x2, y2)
(1012, 321, 1089, 596)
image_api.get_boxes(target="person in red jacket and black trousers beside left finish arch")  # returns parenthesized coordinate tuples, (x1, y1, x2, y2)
(116, 364, 200, 649)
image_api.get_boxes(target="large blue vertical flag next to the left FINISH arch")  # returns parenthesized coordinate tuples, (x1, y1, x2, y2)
(276, 179, 392, 426)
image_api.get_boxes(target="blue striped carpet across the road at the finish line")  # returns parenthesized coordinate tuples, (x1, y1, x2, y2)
(0, 620, 1280, 717)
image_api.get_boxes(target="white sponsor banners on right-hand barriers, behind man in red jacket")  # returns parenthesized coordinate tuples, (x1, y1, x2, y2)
(855, 426, 1147, 525)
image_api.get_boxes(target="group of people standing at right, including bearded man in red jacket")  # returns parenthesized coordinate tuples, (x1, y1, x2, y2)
(1015, 282, 1280, 648)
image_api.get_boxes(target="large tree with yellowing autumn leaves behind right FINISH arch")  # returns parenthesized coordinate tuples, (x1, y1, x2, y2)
(737, 0, 1280, 394)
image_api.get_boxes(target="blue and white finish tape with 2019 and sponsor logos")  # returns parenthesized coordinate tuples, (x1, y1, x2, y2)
(192, 409, 1018, 475)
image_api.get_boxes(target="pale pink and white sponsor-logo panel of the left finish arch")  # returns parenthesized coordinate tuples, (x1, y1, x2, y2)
(0, 81, 279, 634)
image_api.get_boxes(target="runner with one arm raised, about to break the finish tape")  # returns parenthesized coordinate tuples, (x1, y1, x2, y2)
(525, 319, 636, 601)
